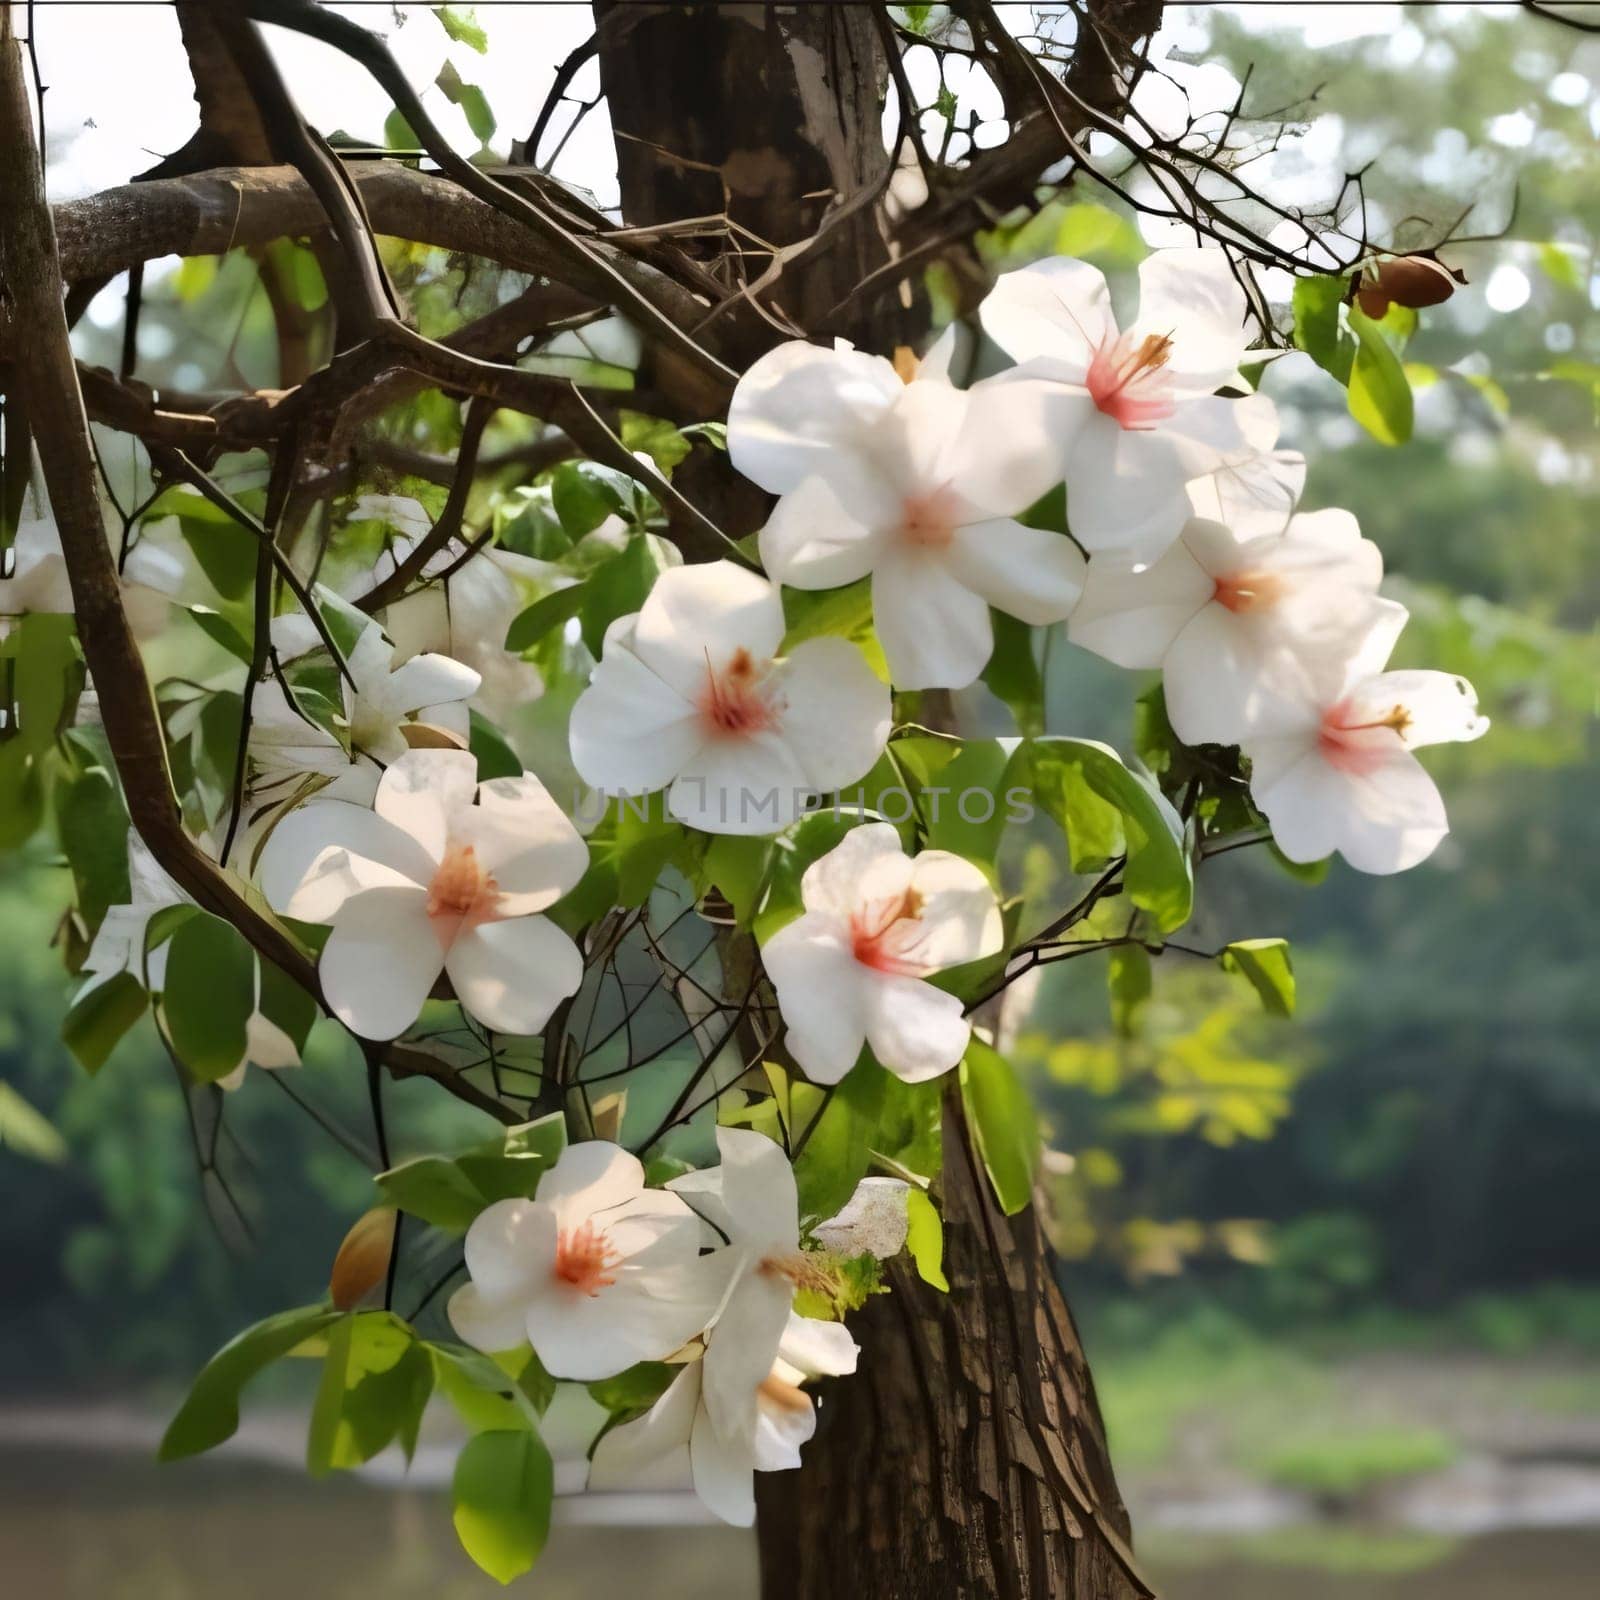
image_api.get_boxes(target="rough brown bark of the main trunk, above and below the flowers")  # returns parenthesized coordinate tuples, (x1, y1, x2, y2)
(595, 0, 1150, 1600)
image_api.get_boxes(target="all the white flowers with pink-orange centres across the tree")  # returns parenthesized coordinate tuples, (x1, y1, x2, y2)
(50, 250, 1486, 1523)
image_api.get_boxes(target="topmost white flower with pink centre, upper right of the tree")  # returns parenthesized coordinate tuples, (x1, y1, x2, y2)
(979, 240, 1251, 560)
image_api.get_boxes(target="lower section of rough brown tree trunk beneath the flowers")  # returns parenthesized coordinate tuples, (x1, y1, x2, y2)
(757, 1093, 1152, 1600)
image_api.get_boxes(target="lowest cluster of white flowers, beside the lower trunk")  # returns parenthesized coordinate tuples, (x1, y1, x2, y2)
(450, 1128, 876, 1526)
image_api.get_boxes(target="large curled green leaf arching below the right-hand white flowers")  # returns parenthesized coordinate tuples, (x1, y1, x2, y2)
(1005, 739, 1194, 933)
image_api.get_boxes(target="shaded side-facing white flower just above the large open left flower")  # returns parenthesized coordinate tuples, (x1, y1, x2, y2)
(250, 614, 480, 798)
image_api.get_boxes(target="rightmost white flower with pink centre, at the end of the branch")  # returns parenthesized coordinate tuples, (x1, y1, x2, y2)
(1240, 606, 1488, 872)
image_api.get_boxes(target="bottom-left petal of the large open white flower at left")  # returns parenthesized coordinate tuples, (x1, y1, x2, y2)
(317, 885, 443, 1038)
